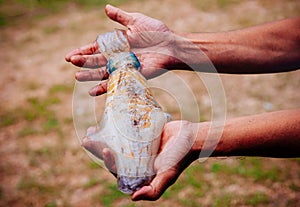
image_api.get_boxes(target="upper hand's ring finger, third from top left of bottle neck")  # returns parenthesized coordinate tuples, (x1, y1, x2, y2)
(75, 68, 109, 81)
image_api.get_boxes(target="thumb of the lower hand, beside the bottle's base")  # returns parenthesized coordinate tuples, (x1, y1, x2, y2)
(131, 169, 178, 201)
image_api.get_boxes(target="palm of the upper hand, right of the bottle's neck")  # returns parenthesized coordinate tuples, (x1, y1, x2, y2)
(127, 14, 172, 77)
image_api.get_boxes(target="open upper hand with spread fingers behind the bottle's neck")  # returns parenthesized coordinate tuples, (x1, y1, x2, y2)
(65, 5, 174, 96)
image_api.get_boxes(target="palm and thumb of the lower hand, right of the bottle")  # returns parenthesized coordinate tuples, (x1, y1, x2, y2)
(131, 121, 198, 201)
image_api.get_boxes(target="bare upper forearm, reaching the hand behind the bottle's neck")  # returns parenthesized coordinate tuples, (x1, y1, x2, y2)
(174, 17, 300, 74)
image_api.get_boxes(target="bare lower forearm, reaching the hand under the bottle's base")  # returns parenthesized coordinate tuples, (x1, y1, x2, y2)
(193, 109, 300, 157)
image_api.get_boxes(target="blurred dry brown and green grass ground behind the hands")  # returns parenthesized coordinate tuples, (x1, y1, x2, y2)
(0, 0, 300, 207)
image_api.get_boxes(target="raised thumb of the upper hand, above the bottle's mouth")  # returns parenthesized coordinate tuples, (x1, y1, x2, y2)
(105, 4, 133, 27)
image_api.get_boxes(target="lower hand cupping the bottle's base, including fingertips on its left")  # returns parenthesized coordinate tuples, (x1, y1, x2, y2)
(82, 121, 198, 201)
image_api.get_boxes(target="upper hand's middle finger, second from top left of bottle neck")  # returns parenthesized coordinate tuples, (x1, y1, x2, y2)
(70, 54, 107, 68)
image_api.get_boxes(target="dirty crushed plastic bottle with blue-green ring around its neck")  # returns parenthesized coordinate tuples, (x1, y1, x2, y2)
(84, 29, 170, 194)
